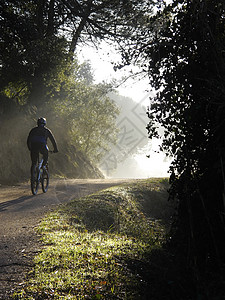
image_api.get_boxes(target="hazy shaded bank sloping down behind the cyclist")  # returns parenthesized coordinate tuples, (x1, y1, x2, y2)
(0, 109, 103, 185)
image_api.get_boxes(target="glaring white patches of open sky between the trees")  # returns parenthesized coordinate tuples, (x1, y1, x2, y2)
(78, 46, 170, 178)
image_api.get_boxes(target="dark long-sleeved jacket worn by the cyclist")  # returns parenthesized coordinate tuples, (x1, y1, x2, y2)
(27, 126, 58, 152)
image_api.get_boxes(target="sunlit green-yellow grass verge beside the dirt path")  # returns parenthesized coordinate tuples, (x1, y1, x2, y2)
(15, 179, 171, 299)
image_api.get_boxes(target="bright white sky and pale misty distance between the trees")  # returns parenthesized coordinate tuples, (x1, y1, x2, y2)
(78, 45, 170, 178)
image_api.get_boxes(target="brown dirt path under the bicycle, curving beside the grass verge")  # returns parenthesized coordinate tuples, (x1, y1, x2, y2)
(0, 179, 134, 300)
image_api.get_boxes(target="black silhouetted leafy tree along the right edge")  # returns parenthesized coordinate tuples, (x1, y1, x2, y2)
(139, 0, 225, 267)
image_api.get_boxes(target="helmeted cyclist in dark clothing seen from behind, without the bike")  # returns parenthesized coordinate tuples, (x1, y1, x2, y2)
(27, 117, 58, 175)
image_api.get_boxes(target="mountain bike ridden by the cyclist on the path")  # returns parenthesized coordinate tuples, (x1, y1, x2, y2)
(31, 151, 53, 195)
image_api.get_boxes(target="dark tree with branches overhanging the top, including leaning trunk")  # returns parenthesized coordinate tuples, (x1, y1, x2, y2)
(0, 0, 156, 111)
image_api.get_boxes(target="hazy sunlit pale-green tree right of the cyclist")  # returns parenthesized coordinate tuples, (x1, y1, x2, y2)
(52, 72, 119, 164)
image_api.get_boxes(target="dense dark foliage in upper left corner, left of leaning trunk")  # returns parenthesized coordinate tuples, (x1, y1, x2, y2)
(0, 0, 67, 106)
